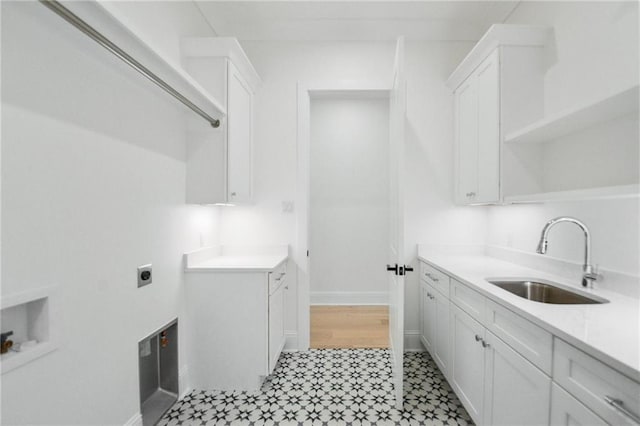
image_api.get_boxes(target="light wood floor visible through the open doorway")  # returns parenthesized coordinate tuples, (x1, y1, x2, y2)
(311, 306, 389, 349)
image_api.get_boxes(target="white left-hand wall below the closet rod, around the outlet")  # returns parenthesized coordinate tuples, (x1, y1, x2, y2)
(2, 2, 216, 425)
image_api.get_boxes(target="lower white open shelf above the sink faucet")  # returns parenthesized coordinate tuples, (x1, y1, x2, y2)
(504, 184, 640, 204)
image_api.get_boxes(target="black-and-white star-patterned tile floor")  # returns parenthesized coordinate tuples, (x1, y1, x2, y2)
(158, 349, 472, 426)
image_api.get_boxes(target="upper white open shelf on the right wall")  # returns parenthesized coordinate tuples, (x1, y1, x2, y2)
(504, 85, 638, 144)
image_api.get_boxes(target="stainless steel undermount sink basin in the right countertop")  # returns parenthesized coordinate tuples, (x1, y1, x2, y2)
(487, 278, 608, 305)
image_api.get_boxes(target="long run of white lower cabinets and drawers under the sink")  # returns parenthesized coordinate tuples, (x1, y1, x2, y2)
(420, 263, 640, 426)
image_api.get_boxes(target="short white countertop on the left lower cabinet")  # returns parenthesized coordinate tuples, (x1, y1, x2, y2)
(184, 246, 289, 272)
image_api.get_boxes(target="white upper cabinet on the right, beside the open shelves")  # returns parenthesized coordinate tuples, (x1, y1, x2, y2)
(447, 25, 548, 204)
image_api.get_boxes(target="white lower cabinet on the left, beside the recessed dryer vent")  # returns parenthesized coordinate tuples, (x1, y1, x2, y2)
(185, 262, 287, 391)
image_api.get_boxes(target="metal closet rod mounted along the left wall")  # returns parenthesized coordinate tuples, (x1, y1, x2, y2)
(40, 0, 220, 128)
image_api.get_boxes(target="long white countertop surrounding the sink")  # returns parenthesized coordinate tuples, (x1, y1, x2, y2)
(418, 253, 640, 381)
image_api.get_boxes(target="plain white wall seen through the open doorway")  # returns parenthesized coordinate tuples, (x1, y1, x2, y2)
(309, 94, 389, 304)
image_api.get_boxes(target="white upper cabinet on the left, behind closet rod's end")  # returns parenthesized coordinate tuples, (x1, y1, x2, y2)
(182, 37, 260, 204)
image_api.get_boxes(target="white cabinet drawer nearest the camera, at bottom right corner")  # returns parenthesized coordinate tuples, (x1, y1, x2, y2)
(553, 338, 640, 425)
